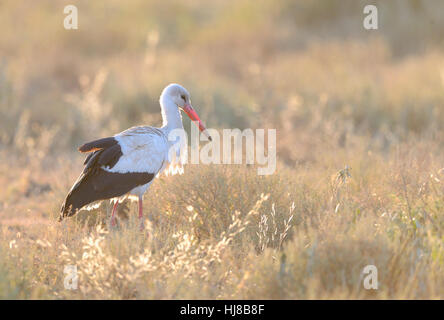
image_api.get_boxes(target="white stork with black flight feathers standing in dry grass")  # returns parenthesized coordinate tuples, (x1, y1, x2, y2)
(59, 84, 211, 229)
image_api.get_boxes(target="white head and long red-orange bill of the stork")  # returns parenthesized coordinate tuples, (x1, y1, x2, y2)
(160, 83, 211, 141)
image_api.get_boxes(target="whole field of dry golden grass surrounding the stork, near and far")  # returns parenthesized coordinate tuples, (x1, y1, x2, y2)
(0, 0, 444, 299)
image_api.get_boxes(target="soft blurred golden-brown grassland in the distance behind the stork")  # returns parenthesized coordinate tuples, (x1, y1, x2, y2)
(0, 0, 444, 164)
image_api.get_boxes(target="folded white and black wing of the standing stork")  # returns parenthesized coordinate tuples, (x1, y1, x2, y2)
(59, 134, 166, 220)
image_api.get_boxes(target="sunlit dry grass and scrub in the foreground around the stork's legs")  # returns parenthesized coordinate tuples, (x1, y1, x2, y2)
(0, 142, 444, 299)
